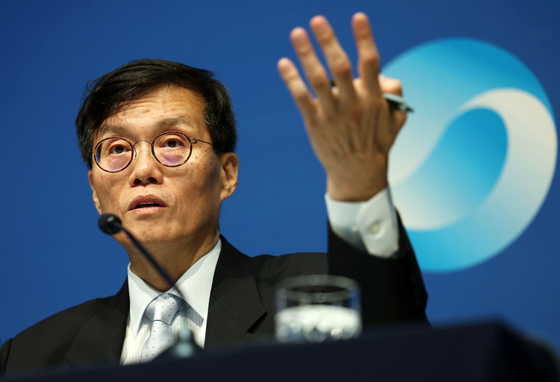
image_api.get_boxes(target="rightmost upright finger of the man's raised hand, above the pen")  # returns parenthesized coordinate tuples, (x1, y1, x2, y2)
(352, 12, 381, 95)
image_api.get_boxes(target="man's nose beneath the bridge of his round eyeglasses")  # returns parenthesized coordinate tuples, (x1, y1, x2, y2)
(129, 140, 163, 186)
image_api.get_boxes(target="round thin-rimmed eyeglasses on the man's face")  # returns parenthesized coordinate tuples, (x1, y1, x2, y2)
(92, 131, 216, 172)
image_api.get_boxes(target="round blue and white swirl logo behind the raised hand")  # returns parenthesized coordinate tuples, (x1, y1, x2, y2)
(383, 38, 557, 272)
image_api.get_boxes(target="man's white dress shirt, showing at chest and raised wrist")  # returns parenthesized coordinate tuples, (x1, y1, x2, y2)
(121, 188, 399, 365)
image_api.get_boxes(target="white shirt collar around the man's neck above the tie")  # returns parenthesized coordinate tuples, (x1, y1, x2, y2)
(128, 239, 222, 336)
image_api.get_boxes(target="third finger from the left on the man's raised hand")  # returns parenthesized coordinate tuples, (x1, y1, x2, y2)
(309, 16, 356, 101)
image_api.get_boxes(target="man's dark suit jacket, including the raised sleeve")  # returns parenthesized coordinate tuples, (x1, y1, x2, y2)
(0, 227, 427, 374)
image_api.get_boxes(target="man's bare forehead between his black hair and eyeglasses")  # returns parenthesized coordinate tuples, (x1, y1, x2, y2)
(96, 86, 207, 137)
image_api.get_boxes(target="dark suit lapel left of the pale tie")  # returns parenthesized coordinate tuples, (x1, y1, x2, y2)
(66, 281, 130, 366)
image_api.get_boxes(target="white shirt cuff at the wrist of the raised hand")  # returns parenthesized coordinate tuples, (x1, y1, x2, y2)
(325, 188, 399, 257)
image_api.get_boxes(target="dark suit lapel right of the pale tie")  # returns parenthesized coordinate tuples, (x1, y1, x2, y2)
(205, 236, 266, 346)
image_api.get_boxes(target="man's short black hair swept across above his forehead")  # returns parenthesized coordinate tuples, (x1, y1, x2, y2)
(76, 59, 237, 168)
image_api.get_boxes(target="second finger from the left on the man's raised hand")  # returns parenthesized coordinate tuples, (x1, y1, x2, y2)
(290, 28, 335, 110)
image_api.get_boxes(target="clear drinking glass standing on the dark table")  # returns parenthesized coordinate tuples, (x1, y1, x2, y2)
(274, 275, 362, 343)
